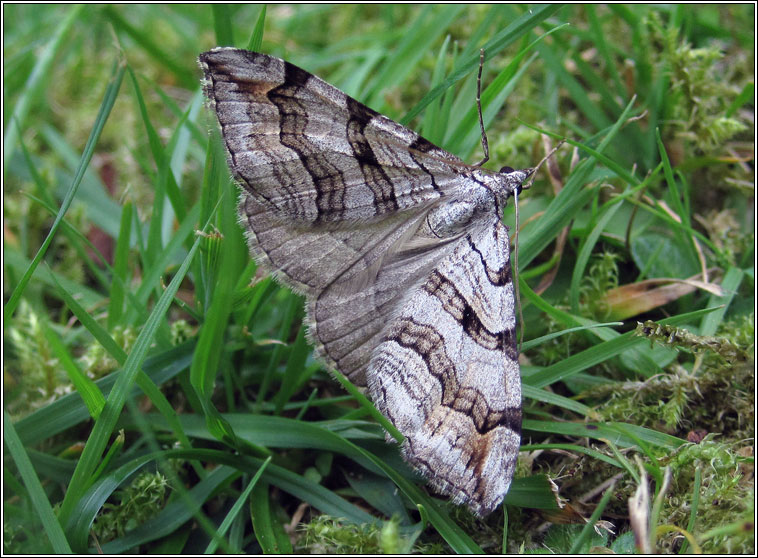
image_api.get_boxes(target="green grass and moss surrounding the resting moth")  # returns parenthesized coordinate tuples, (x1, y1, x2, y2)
(3, 5, 755, 554)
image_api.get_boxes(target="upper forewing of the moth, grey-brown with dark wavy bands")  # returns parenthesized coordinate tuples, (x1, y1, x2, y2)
(199, 48, 470, 227)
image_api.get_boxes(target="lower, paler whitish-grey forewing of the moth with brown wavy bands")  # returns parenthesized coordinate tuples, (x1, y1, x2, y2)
(368, 221, 521, 515)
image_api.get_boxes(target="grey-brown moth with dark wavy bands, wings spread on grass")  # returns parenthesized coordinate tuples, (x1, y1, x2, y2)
(199, 48, 533, 515)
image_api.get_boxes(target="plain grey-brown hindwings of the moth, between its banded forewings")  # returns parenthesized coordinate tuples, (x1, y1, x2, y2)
(240, 190, 464, 386)
